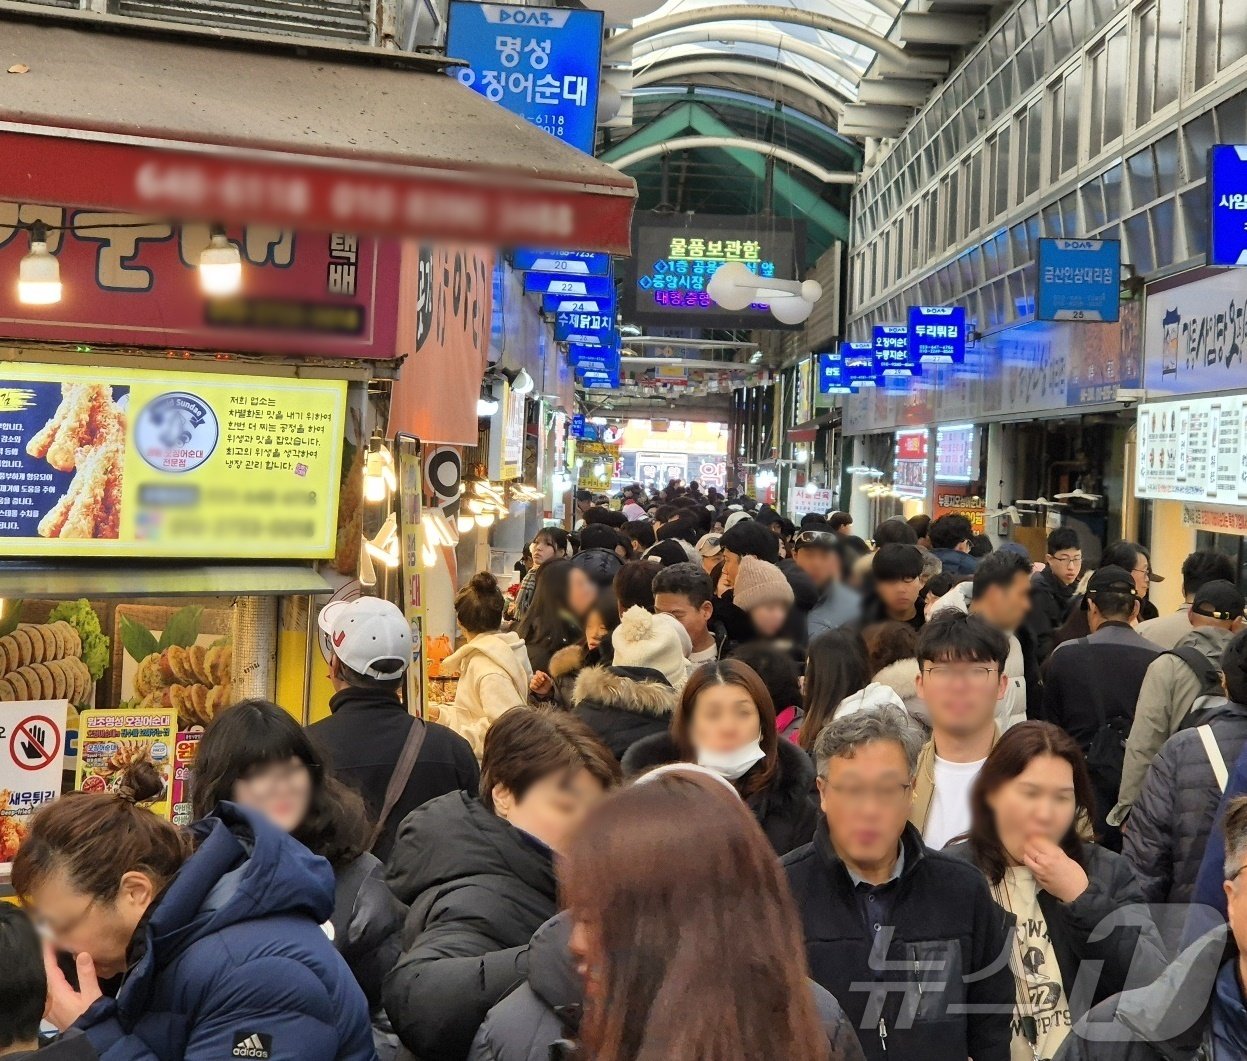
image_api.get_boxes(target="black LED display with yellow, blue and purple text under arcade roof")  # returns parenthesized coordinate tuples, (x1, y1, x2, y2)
(624, 213, 806, 329)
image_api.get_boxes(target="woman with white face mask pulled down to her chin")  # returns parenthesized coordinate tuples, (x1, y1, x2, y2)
(624, 660, 818, 854)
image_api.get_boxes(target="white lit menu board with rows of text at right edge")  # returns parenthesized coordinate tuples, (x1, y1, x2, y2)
(1135, 395, 1247, 505)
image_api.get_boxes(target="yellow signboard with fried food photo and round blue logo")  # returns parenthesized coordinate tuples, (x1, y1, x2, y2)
(0, 364, 347, 559)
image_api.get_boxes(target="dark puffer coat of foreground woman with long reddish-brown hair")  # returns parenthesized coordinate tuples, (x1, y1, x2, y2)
(468, 913, 864, 1061)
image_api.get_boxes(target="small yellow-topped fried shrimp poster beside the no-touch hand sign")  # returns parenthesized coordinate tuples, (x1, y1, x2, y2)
(75, 711, 177, 818)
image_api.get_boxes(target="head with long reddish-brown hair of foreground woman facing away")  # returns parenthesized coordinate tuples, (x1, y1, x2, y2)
(560, 771, 860, 1061)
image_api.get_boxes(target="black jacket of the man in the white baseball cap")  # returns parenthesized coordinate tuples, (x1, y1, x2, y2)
(308, 688, 480, 862)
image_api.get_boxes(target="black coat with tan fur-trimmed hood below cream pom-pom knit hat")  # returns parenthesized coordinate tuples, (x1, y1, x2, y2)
(571, 667, 680, 759)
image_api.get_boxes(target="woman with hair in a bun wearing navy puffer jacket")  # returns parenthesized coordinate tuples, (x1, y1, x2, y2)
(12, 762, 377, 1061)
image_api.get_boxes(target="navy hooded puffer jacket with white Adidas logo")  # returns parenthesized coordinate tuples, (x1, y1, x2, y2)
(75, 803, 377, 1061)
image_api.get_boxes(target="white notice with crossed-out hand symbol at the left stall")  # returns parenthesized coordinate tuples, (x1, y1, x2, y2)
(0, 699, 69, 876)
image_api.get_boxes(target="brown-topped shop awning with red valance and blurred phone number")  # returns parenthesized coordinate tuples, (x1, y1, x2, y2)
(0, 0, 636, 253)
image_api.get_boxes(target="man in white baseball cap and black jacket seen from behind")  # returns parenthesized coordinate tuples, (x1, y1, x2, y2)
(308, 597, 480, 862)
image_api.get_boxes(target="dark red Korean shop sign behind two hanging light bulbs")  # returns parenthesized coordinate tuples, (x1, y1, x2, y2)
(0, 202, 399, 358)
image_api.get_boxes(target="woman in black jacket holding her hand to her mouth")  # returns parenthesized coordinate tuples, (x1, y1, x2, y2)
(946, 722, 1165, 1061)
